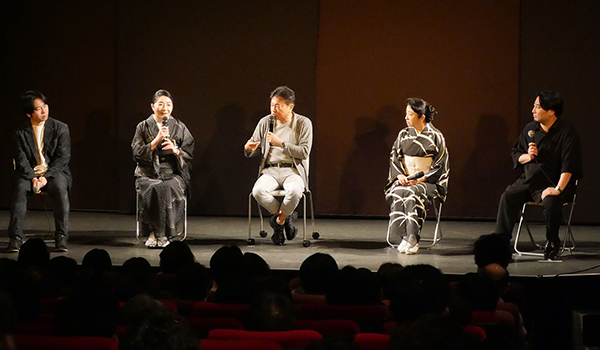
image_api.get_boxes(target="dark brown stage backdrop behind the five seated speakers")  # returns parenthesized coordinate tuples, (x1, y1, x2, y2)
(0, 0, 600, 223)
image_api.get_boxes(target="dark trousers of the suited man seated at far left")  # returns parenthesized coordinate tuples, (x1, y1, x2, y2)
(8, 174, 69, 239)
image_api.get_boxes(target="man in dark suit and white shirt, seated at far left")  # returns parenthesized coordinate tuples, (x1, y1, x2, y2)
(6, 91, 72, 252)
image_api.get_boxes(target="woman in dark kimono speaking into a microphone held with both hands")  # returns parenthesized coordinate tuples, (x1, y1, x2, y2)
(131, 90, 194, 248)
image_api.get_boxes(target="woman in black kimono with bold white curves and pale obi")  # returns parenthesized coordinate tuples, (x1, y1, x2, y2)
(385, 98, 450, 254)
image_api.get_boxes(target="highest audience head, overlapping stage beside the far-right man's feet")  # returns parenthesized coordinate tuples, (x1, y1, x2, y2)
(473, 233, 512, 269)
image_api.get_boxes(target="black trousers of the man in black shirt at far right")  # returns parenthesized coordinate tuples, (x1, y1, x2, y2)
(496, 184, 573, 242)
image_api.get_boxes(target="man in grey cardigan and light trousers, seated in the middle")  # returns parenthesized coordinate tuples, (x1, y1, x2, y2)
(244, 86, 313, 245)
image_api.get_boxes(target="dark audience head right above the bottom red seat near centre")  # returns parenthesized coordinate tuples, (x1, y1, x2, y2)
(244, 293, 295, 331)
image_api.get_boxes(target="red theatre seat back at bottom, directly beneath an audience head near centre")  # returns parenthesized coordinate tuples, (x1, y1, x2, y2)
(208, 329, 323, 349)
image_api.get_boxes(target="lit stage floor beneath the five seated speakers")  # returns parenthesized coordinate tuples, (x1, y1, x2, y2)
(0, 211, 600, 276)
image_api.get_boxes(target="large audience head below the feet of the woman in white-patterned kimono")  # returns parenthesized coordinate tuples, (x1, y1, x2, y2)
(390, 265, 450, 322)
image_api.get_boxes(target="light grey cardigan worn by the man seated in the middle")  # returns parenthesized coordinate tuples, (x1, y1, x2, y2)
(244, 113, 313, 190)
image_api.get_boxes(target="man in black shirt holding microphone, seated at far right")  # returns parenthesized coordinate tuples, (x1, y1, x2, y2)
(496, 91, 583, 259)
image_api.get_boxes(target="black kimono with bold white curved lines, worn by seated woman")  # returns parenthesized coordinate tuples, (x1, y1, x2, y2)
(385, 123, 450, 244)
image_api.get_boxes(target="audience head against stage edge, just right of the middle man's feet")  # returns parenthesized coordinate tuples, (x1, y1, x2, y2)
(299, 253, 338, 294)
